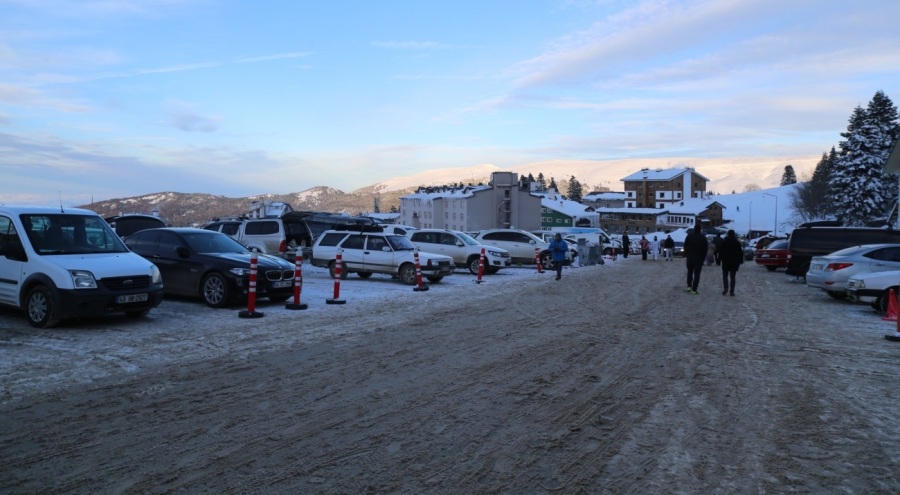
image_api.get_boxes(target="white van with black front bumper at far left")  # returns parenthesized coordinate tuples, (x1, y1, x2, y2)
(0, 205, 163, 328)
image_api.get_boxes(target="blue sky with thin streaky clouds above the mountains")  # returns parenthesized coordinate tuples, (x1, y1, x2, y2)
(0, 0, 900, 206)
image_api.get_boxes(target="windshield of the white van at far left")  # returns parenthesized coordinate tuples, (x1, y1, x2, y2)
(20, 213, 128, 255)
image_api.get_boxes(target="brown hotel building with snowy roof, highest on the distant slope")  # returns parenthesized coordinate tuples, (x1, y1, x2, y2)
(621, 167, 709, 208)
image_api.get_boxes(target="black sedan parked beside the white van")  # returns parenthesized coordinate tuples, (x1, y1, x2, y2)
(125, 228, 294, 308)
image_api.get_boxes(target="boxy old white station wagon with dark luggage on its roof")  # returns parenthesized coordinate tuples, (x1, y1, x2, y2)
(312, 226, 454, 285)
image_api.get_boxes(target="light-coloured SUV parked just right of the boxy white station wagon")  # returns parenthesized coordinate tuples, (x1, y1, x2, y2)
(407, 229, 512, 275)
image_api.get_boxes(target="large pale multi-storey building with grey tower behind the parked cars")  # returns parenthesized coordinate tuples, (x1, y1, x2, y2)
(399, 172, 541, 232)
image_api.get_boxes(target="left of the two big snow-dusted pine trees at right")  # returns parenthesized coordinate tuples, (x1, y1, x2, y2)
(829, 106, 885, 226)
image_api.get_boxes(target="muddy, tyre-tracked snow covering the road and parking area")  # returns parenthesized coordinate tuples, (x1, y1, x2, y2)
(0, 257, 900, 495)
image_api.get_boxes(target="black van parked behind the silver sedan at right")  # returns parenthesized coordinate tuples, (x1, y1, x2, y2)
(784, 227, 900, 277)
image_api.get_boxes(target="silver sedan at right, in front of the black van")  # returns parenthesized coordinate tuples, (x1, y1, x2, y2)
(806, 244, 900, 299)
